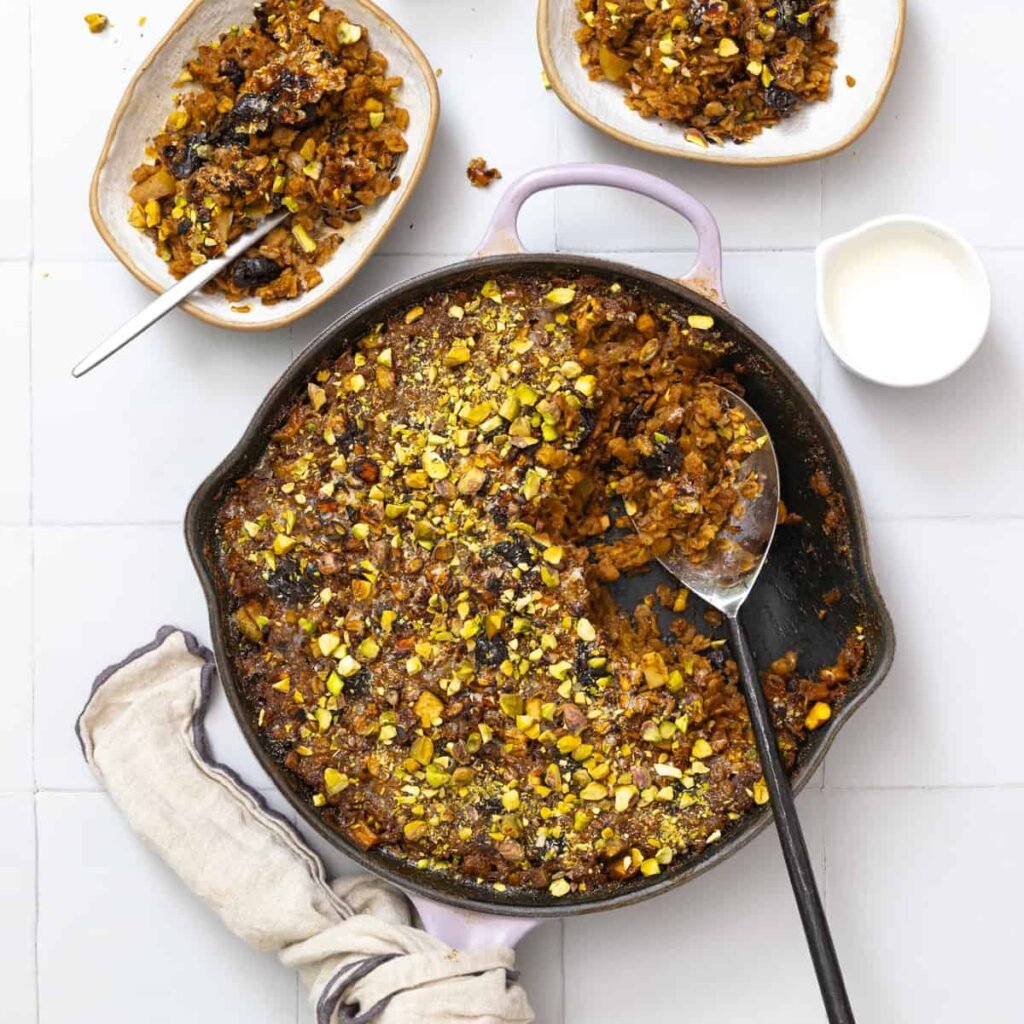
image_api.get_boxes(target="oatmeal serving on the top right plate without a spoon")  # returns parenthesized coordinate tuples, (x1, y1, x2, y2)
(577, 0, 838, 148)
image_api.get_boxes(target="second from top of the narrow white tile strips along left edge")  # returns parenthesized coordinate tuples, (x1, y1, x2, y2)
(0, 264, 31, 523)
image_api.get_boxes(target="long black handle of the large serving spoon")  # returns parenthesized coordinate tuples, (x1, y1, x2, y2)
(728, 616, 854, 1024)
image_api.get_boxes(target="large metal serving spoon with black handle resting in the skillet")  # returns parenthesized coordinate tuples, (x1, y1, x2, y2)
(634, 384, 854, 1024)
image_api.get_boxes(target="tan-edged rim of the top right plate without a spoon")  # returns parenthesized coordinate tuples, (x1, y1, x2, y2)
(537, 0, 907, 167)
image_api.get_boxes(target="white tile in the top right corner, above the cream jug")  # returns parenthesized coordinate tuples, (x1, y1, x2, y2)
(823, 0, 1024, 246)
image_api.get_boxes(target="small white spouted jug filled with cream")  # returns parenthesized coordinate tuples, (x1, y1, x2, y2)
(817, 216, 991, 387)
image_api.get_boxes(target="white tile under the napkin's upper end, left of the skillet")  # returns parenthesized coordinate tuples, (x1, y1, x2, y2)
(35, 525, 271, 790)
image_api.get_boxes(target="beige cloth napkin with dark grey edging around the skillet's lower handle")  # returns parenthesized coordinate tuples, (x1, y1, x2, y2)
(78, 628, 534, 1024)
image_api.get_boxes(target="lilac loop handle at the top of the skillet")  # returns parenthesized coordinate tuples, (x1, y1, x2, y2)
(474, 164, 725, 305)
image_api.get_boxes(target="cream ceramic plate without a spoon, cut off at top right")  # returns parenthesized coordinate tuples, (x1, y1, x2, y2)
(538, 0, 906, 166)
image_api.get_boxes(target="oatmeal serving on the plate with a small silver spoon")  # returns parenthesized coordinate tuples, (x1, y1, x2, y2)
(128, 0, 409, 304)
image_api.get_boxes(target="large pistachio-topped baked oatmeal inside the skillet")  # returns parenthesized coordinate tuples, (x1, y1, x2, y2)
(217, 274, 863, 897)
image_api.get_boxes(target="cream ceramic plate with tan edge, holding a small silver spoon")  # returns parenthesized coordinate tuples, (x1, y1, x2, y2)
(89, 0, 440, 331)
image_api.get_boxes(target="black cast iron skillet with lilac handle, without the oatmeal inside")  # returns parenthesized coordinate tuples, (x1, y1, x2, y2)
(185, 164, 895, 927)
